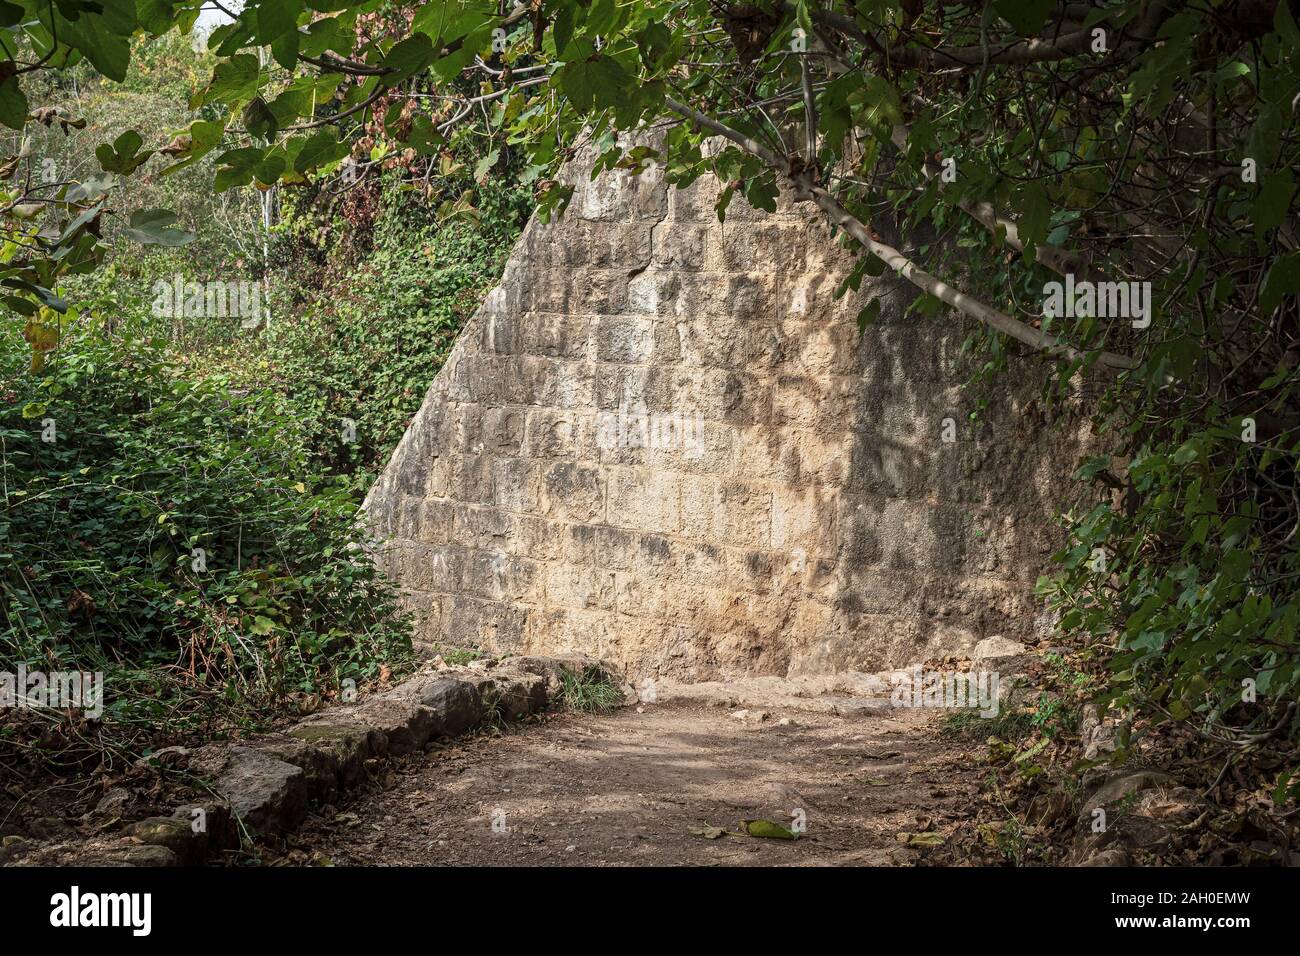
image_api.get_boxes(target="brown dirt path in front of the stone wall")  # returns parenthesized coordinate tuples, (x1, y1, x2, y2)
(281, 700, 979, 866)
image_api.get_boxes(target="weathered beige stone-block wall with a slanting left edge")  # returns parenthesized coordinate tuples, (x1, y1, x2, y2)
(367, 141, 1078, 680)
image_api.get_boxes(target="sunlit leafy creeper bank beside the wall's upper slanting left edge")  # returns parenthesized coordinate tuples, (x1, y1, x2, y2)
(215, 164, 530, 489)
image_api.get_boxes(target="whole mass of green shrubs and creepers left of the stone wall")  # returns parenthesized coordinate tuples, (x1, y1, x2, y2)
(0, 24, 530, 732)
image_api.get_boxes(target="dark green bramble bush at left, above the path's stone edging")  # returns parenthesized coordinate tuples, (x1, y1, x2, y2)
(0, 317, 410, 722)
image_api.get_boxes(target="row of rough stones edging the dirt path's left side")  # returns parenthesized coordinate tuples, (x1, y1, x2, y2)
(8, 656, 605, 866)
